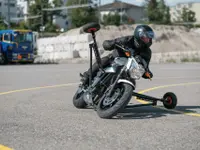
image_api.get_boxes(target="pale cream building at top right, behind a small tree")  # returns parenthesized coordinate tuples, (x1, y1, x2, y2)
(170, 2, 200, 23)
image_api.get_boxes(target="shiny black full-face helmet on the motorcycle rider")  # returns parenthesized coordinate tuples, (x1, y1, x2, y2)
(134, 25, 154, 48)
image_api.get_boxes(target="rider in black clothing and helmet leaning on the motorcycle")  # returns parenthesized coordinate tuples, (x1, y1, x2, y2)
(81, 25, 154, 84)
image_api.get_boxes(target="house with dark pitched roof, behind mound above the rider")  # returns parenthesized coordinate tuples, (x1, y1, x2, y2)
(99, 0, 145, 23)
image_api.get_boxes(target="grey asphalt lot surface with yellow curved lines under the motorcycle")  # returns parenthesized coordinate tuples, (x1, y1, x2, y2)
(0, 63, 200, 150)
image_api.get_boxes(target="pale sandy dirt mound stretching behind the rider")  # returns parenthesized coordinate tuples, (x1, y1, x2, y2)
(61, 24, 200, 52)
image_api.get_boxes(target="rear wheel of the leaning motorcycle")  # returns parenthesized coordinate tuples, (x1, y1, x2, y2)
(73, 86, 87, 108)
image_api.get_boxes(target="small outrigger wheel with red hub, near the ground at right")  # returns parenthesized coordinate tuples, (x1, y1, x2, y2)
(163, 92, 177, 109)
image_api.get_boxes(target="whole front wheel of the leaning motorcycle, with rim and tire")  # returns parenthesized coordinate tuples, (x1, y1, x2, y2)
(97, 83, 133, 119)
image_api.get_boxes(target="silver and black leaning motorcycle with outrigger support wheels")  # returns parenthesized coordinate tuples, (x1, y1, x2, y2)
(73, 23, 177, 119)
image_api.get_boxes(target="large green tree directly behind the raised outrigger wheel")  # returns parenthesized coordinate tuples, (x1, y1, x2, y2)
(67, 0, 98, 28)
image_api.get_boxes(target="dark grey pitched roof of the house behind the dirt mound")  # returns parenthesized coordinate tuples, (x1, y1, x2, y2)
(99, 1, 141, 11)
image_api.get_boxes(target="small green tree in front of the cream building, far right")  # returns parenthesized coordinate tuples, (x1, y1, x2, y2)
(181, 7, 196, 22)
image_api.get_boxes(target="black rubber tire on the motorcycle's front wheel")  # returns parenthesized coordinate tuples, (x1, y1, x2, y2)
(97, 83, 133, 119)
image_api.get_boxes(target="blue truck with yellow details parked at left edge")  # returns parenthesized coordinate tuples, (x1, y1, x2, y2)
(0, 30, 36, 64)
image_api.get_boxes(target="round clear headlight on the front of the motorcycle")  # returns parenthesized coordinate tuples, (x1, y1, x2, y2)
(129, 65, 145, 80)
